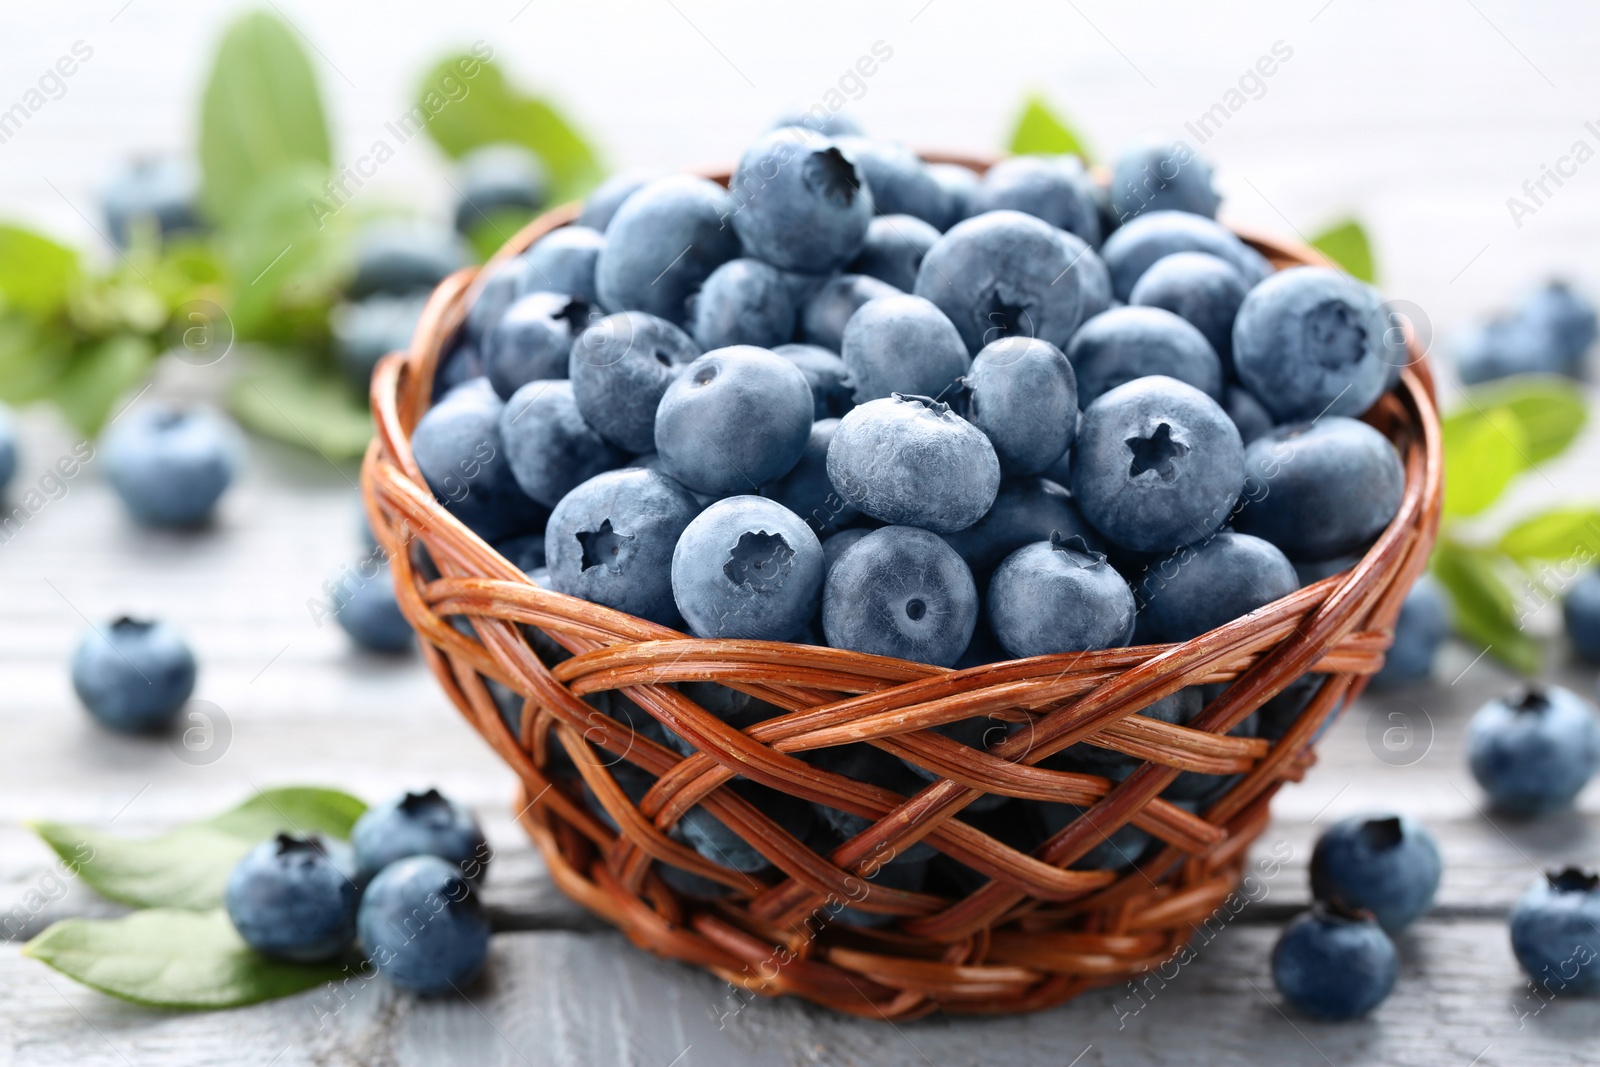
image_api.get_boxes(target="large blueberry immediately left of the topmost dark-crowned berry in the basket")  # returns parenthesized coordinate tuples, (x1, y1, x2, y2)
(595, 174, 739, 326)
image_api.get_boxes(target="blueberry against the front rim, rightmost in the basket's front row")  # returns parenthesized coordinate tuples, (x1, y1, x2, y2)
(1136, 530, 1299, 641)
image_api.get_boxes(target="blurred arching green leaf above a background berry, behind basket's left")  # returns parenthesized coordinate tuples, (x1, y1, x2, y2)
(416, 54, 603, 203)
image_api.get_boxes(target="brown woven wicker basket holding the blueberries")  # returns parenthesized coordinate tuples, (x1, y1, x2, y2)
(362, 160, 1440, 1019)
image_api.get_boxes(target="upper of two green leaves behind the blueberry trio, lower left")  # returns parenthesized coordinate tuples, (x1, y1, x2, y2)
(34, 785, 366, 908)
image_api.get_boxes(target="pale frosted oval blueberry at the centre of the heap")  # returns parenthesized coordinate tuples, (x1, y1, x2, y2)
(827, 394, 1000, 533)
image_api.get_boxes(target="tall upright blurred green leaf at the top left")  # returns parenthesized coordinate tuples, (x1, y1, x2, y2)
(200, 11, 333, 226)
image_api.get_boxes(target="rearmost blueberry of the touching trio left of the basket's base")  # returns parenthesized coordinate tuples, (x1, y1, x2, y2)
(350, 789, 490, 885)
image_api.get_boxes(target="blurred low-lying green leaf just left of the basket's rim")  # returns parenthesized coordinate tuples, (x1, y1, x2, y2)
(227, 352, 373, 461)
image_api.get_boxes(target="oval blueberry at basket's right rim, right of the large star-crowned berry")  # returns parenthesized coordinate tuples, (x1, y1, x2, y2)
(1234, 416, 1405, 560)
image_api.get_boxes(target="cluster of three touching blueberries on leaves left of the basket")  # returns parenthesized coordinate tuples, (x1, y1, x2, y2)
(224, 789, 490, 995)
